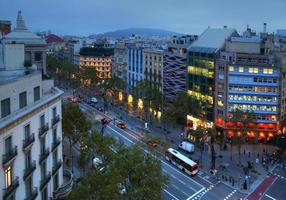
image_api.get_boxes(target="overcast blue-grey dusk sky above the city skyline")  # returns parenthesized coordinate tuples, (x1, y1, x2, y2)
(0, 0, 286, 35)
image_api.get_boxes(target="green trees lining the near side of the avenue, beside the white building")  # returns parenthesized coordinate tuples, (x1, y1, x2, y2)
(62, 103, 168, 200)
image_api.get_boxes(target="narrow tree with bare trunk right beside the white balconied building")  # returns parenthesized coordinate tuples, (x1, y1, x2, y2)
(62, 103, 91, 170)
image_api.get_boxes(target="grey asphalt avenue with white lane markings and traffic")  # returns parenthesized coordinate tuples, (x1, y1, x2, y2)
(76, 103, 248, 200)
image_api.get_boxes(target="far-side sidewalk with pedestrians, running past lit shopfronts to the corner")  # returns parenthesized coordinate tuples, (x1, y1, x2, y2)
(66, 85, 284, 193)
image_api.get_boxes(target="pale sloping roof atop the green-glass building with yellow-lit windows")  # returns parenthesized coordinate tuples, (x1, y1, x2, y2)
(188, 28, 237, 53)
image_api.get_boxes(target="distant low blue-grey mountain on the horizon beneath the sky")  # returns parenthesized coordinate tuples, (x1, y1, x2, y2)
(90, 28, 182, 38)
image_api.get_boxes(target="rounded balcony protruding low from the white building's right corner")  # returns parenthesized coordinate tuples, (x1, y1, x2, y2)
(53, 169, 73, 199)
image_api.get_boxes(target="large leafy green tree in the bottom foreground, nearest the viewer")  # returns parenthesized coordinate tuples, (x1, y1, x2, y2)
(68, 131, 168, 200)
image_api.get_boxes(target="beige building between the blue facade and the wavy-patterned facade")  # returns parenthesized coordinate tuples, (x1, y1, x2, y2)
(143, 48, 163, 92)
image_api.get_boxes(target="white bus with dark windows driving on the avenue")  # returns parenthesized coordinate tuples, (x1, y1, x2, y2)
(165, 148, 198, 176)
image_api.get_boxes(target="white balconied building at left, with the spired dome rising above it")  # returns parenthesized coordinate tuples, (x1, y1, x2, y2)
(0, 12, 72, 200)
